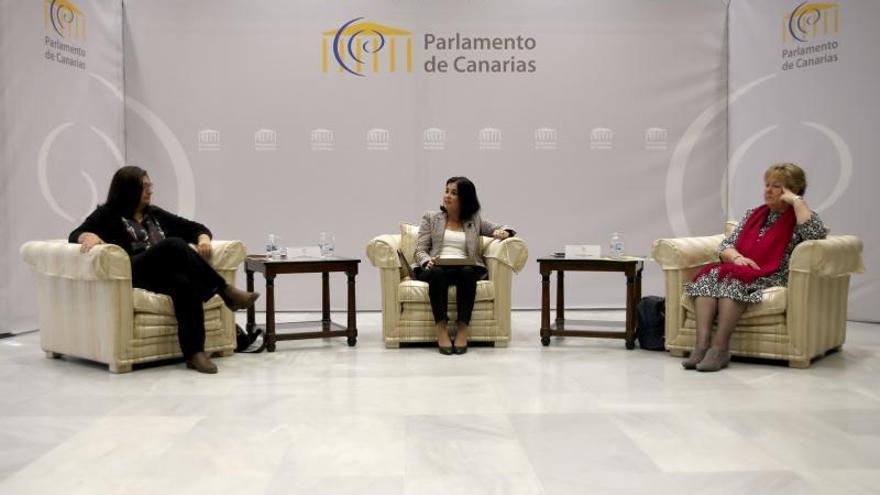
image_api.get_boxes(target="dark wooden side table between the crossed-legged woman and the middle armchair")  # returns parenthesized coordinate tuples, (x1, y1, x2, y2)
(244, 255, 361, 352)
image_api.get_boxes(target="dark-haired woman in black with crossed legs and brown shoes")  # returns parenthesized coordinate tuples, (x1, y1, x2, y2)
(68, 166, 259, 373)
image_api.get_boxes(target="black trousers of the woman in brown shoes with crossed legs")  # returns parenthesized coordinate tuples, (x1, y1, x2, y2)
(131, 237, 226, 359)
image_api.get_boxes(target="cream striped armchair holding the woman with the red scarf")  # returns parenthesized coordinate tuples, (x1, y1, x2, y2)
(651, 222, 864, 368)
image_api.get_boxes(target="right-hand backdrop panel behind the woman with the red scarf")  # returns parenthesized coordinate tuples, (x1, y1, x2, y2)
(730, 0, 880, 321)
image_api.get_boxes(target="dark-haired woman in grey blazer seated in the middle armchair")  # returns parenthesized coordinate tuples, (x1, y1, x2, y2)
(415, 177, 516, 355)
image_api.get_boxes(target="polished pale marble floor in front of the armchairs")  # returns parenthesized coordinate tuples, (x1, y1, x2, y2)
(0, 312, 880, 495)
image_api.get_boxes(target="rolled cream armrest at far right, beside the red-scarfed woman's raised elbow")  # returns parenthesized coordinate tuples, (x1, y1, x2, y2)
(789, 235, 865, 277)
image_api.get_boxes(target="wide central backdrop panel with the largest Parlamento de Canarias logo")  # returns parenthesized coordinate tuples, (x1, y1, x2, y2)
(118, 0, 726, 316)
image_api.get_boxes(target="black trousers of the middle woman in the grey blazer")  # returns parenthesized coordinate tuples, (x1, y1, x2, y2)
(416, 265, 486, 325)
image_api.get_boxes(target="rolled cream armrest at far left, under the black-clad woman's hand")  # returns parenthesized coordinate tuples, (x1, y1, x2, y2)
(21, 240, 131, 280)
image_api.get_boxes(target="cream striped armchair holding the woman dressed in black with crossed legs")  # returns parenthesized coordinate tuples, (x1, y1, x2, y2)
(21, 240, 245, 373)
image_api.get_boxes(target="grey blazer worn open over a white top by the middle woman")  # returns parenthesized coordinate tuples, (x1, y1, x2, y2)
(415, 211, 516, 268)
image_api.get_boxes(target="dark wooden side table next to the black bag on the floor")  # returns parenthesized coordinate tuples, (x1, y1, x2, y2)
(538, 256, 645, 349)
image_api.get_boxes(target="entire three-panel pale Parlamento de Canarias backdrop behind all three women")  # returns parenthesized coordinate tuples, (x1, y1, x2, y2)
(0, 0, 880, 331)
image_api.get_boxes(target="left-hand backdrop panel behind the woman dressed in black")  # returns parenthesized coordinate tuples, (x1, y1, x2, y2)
(0, 0, 125, 333)
